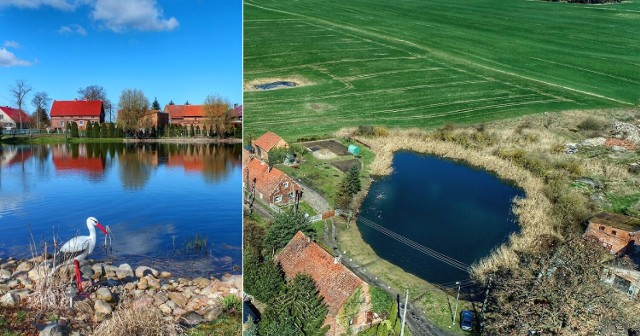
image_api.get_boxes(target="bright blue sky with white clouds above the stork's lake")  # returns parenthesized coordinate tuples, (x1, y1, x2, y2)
(0, 0, 242, 119)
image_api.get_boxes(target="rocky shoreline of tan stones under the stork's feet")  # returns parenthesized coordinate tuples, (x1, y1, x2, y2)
(0, 257, 242, 335)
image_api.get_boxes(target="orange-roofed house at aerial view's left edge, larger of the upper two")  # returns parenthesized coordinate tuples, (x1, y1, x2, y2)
(242, 155, 301, 206)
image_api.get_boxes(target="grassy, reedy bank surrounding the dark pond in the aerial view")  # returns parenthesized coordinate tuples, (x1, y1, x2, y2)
(328, 109, 640, 329)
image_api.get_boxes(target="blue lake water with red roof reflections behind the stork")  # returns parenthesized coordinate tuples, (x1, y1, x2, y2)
(0, 144, 242, 276)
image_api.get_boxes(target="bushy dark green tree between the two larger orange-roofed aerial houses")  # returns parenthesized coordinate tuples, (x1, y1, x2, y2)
(263, 210, 315, 250)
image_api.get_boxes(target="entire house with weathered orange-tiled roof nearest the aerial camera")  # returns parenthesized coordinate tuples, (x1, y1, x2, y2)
(276, 231, 380, 335)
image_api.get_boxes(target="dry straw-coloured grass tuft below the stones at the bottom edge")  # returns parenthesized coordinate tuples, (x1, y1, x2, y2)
(93, 304, 182, 336)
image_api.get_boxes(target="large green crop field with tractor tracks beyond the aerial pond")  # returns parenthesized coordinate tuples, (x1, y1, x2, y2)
(244, 0, 640, 140)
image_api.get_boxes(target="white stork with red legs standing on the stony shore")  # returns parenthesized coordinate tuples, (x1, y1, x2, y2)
(53, 217, 109, 292)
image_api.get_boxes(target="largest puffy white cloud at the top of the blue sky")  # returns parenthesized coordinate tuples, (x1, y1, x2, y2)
(91, 0, 179, 32)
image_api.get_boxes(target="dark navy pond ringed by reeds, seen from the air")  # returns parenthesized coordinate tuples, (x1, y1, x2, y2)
(358, 152, 524, 284)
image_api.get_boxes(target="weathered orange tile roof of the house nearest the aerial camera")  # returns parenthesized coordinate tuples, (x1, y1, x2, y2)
(276, 231, 364, 316)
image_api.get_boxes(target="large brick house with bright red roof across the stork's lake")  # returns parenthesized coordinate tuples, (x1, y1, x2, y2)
(51, 99, 104, 129)
